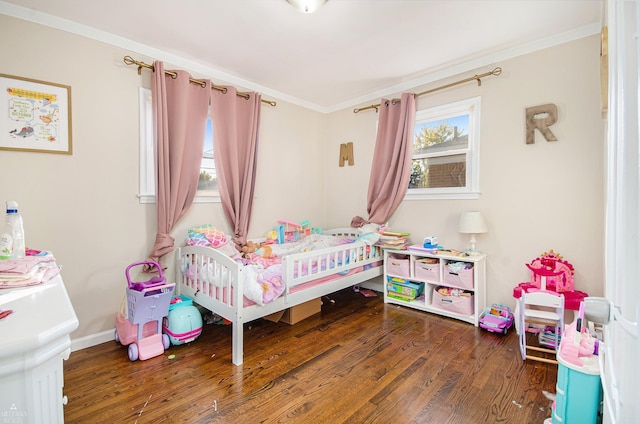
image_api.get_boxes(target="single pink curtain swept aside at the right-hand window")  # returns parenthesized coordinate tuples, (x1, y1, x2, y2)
(367, 93, 416, 224)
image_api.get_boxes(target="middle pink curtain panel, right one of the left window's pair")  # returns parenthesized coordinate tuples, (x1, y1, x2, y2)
(211, 87, 261, 248)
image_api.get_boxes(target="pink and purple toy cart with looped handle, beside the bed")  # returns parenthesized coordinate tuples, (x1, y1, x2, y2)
(115, 261, 175, 361)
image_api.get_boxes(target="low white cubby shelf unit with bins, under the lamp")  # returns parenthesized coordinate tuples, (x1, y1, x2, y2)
(383, 249, 486, 327)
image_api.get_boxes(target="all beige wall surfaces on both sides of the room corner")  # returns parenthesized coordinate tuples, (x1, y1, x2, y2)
(0, 15, 604, 340)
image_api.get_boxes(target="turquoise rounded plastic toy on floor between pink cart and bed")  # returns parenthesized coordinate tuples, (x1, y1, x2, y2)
(162, 295, 202, 345)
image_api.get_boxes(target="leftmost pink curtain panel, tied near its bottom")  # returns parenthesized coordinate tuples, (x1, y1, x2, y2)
(149, 61, 212, 263)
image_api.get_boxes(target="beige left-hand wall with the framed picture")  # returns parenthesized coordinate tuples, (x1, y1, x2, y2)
(0, 15, 327, 339)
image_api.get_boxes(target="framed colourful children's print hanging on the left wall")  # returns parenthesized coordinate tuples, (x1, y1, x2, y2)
(0, 74, 72, 155)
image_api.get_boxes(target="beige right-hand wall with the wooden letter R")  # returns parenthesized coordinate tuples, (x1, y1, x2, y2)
(325, 36, 605, 306)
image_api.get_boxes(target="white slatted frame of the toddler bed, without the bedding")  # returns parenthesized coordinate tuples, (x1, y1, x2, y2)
(176, 228, 383, 365)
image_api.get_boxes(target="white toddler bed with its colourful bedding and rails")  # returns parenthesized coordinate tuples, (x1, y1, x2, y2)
(176, 228, 382, 365)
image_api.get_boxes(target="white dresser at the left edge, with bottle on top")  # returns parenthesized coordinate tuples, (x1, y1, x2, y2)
(0, 275, 78, 424)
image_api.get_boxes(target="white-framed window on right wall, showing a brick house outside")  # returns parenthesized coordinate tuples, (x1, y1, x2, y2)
(405, 97, 480, 199)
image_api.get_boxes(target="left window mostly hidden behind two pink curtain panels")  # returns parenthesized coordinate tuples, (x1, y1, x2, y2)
(139, 88, 220, 203)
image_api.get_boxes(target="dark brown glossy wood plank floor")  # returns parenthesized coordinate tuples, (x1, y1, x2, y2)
(64, 289, 557, 424)
